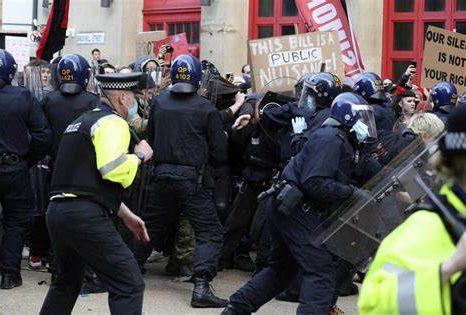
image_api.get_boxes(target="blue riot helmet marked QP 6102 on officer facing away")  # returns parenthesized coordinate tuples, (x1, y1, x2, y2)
(170, 55, 202, 94)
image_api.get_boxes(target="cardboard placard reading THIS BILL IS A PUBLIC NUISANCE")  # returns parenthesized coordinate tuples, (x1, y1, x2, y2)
(248, 31, 344, 92)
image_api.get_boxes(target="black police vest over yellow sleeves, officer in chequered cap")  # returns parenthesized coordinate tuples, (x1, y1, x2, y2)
(50, 111, 123, 211)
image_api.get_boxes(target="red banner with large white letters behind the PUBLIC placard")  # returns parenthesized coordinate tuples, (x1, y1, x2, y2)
(295, 0, 364, 77)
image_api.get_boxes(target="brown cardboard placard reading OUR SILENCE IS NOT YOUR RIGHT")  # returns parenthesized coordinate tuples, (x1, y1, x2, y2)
(421, 26, 466, 94)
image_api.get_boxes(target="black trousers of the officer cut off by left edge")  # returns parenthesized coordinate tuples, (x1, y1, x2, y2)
(0, 166, 34, 273)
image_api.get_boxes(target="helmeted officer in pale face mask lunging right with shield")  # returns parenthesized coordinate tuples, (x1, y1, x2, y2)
(222, 93, 374, 314)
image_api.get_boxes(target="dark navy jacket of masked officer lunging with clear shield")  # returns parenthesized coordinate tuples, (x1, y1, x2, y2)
(282, 126, 356, 210)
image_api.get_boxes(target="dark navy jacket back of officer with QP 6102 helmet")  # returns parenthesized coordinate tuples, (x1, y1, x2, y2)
(148, 92, 227, 168)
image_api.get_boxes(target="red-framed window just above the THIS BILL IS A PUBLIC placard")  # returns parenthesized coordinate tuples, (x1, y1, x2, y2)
(249, 0, 305, 39)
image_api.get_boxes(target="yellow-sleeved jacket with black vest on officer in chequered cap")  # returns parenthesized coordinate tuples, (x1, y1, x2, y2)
(51, 109, 140, 212)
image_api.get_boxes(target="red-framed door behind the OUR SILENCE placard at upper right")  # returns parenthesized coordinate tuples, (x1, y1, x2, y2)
(382, 0, 466, 84)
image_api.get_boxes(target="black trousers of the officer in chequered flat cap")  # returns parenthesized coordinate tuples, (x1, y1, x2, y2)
(40, 199, 144, 315)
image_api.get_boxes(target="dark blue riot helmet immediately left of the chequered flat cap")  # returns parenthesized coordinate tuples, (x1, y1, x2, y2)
(57, 54, 91, 94)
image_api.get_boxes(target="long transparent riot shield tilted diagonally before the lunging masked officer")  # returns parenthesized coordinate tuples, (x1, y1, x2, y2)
(311, 135, 443, 266)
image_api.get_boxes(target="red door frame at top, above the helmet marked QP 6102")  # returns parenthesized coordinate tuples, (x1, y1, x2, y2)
(143, 0, 201, 57)
